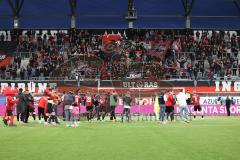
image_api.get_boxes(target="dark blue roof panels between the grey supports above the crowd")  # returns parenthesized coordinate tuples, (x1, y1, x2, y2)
(0, 0, 240, 29)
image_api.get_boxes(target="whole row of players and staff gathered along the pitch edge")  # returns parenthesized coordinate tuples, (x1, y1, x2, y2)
(3, 89, 203, 127)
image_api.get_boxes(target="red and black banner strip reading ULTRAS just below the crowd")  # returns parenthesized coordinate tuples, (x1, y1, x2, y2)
(0, 80, 240, 94)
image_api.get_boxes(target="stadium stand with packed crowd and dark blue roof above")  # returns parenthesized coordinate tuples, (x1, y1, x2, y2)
(0, 0, 240, 80)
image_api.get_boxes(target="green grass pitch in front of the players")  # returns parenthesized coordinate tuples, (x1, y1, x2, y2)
(0, 117, 240, 160)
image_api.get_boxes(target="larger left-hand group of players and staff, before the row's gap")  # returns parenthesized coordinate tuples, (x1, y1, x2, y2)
(3, 88, 133, 127)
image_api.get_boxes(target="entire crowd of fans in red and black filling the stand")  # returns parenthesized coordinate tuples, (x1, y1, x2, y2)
(1, 30, 240, 79)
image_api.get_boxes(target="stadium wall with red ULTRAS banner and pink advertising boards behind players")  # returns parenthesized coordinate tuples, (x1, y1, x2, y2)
(0, 80, 240, 116)
